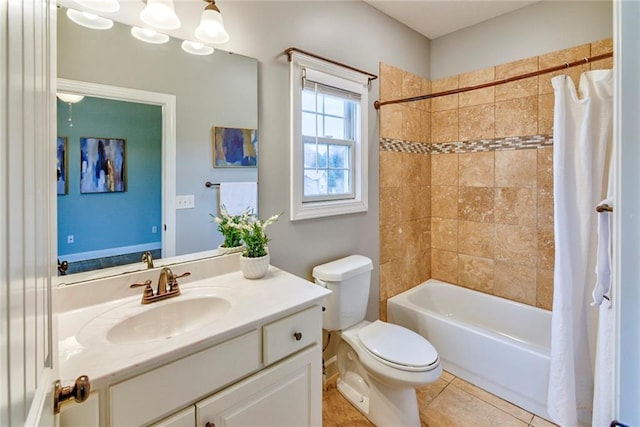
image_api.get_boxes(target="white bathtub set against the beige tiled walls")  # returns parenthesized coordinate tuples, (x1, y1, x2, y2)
(387, 279, 551, 419)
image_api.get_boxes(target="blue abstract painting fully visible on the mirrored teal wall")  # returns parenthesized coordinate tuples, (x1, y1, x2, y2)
(80, 137, 125, 193)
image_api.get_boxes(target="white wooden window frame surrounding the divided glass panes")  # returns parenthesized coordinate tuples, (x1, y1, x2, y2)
(290, 52, 369, 221)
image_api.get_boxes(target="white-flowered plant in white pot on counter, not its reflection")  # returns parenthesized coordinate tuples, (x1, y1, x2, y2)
(230, 212, 282, 279)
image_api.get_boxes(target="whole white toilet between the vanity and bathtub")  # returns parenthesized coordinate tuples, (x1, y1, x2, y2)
(313, 255, 442, 427)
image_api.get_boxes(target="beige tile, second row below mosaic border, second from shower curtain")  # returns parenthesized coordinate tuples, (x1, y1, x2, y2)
(495, 188, 538, 227)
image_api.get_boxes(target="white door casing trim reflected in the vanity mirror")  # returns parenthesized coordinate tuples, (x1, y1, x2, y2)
(54, 79, 176, 258)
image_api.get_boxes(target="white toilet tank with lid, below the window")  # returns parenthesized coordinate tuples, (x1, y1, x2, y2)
(312, 255, 373, 331)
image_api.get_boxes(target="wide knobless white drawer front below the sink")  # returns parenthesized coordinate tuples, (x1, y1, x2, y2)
(109, 331, 260, 426)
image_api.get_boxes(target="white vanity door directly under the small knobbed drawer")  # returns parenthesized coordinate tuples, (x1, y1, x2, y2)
(196, 344, 322, 427)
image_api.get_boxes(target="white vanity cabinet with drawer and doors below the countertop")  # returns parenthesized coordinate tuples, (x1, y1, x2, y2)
(61, 305, 322, 427)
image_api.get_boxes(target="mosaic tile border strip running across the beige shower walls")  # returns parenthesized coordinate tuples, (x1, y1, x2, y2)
(380, 134, 553, 154)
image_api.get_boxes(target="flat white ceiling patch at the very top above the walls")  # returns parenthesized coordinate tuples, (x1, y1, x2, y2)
(363, 0, 537, 39)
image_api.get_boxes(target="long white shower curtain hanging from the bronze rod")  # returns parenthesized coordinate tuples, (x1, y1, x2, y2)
(547, 70, 613, 427)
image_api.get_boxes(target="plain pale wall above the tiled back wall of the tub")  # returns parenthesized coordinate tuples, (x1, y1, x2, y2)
(431, 1, 613, 80)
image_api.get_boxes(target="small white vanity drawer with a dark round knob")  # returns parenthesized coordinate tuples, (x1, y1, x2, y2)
(262, 306, 322, 365)
